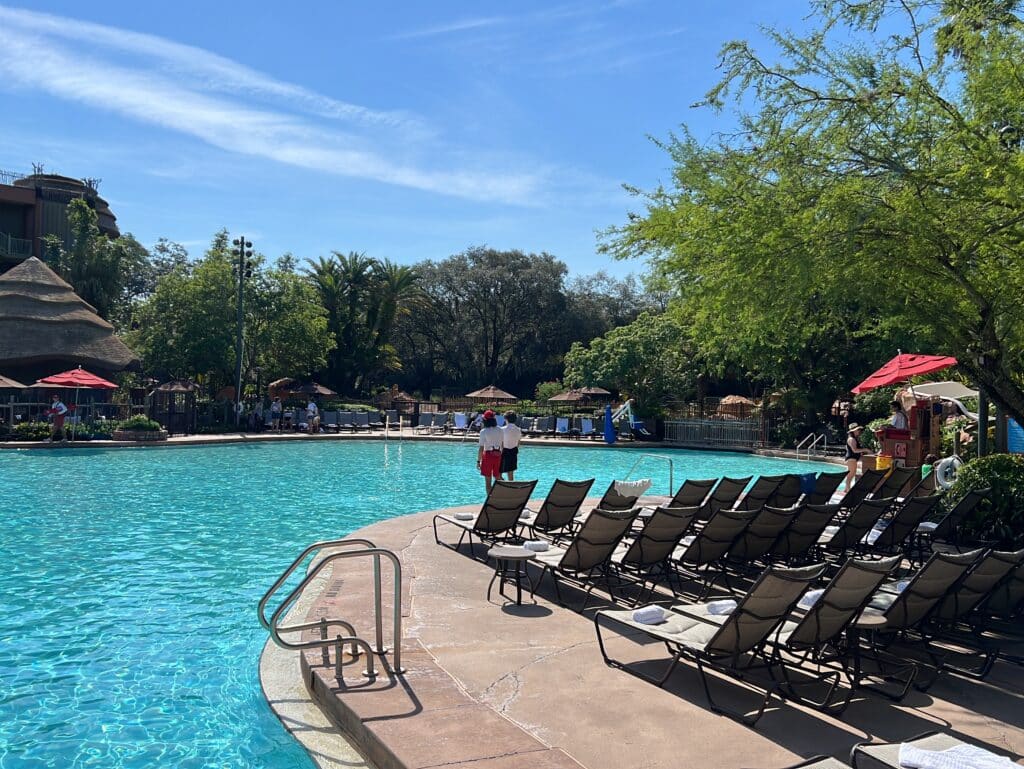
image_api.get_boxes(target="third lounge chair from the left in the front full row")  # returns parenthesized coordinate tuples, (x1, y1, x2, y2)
(854, 550, 983, 701)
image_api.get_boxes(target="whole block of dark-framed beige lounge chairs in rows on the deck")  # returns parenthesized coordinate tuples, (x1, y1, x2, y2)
(434, 472, 1024, 723)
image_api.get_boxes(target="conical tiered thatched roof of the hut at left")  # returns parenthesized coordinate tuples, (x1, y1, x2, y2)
(0, 257, 139, 381)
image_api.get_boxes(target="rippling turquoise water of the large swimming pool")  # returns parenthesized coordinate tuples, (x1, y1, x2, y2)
(0, 441, 838, 769)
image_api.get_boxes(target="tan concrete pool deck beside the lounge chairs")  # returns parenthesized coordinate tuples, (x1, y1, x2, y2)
(260, 498, 1024, 769)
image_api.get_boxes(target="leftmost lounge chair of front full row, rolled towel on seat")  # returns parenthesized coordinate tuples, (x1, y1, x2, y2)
(594, 564, 824, 725)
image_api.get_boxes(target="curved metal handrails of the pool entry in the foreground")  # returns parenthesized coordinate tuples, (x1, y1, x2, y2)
(257, 539, 406, 679)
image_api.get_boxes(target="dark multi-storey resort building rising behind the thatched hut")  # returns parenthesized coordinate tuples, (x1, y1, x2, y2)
(0, 171, 121, 272)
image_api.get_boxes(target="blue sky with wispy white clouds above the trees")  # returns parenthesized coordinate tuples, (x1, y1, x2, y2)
(0, 0, 808, 275)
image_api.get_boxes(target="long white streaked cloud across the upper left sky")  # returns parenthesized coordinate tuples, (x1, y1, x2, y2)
(0, 6, 543, 205)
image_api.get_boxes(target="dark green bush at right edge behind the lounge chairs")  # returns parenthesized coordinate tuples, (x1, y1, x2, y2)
(948, 454, 1024, 548)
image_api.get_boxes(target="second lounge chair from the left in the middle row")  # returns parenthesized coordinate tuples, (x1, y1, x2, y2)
(611, 506, 700, 604)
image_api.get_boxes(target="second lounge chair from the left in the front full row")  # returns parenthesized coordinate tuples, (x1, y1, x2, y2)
(769, 556, 900, 715)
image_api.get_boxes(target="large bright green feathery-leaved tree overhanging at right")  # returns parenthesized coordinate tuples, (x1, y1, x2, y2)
(604, 0, 1024, 419)
